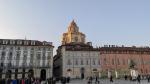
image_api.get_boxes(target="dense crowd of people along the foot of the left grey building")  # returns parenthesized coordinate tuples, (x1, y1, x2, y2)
(0, 78, 56, 84)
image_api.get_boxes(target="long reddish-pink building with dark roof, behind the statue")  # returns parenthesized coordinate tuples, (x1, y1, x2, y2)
(100, 45, 150, 77)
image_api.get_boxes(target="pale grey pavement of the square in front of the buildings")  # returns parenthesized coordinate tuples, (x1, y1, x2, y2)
(56, 79, 150, 84)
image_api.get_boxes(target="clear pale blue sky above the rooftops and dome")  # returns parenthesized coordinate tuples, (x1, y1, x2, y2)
(0, 0, 150, 53)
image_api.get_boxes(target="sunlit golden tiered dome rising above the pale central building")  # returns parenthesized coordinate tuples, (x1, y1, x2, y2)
(62, 20, 86, 45)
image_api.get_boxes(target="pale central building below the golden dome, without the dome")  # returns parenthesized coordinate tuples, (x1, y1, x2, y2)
(54, 44, 101, 78)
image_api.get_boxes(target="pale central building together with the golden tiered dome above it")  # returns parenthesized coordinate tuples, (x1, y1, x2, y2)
(54, 21, 101, 78)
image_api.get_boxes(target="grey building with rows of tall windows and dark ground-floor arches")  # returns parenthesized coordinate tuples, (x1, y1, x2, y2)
(0, 39, 54, 80)
